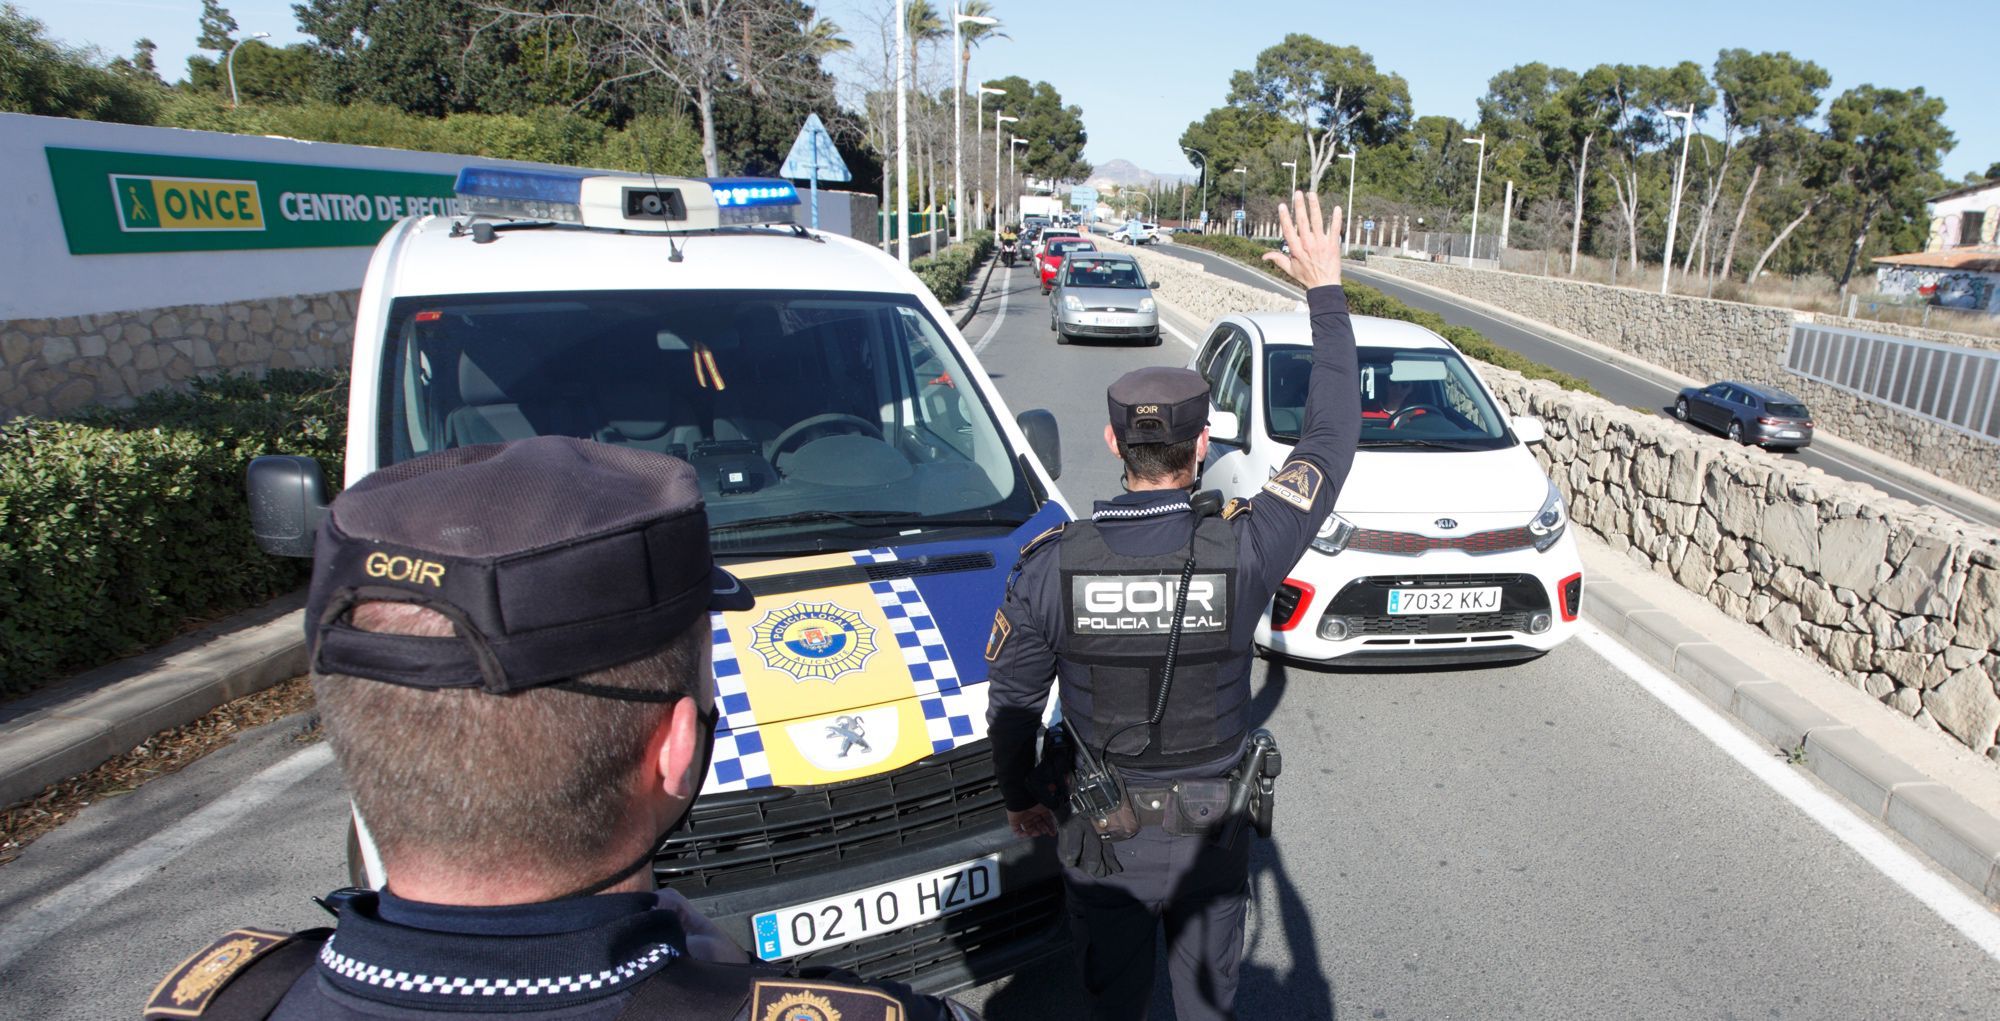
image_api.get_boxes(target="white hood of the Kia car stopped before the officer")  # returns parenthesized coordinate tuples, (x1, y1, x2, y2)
(1334, 444, 1548, 525)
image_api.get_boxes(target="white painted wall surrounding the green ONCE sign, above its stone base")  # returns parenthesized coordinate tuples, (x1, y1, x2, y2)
(0, 114, 872, 320)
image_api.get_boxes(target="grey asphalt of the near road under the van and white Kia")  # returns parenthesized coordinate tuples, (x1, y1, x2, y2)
(0, 260, 2000, 1021)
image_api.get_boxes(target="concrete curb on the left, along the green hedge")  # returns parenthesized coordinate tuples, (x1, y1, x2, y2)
(0, 593, 306, 805)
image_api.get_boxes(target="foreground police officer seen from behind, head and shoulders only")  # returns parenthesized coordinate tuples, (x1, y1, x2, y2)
(146, 436, 972, 1021)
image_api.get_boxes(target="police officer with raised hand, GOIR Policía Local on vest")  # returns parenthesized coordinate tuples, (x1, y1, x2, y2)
(986, 192, 1360, 1019)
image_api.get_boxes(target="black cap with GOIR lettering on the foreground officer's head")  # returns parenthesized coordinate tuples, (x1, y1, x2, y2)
(306, 436, 752, 695)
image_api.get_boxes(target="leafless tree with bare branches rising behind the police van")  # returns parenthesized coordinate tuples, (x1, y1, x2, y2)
(480, 0, 826, 176)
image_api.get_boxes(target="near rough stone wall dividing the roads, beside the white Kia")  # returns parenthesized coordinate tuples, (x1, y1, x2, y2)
(1138, 250, 2000, 761)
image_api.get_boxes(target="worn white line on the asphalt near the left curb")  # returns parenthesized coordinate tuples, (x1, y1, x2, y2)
(0, 741, 334, 969)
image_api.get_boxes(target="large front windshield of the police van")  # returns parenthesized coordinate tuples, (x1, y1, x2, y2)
(378, 290, 1036, 555)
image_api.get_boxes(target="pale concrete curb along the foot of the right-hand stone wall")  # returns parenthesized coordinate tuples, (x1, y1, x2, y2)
(1584, 583, 2000, 905)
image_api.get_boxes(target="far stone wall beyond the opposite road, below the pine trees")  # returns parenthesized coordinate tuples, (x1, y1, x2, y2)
(1368, 258, 2000, 494)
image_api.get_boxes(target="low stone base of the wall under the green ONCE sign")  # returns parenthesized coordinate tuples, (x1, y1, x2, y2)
(0, 290, 358, 420)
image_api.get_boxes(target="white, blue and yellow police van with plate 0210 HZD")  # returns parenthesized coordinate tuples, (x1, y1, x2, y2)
(250, 168, 1068, 991)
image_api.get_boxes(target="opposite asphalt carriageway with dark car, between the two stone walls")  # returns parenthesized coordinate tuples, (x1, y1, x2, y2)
(1148, 236, 2000, 525)
